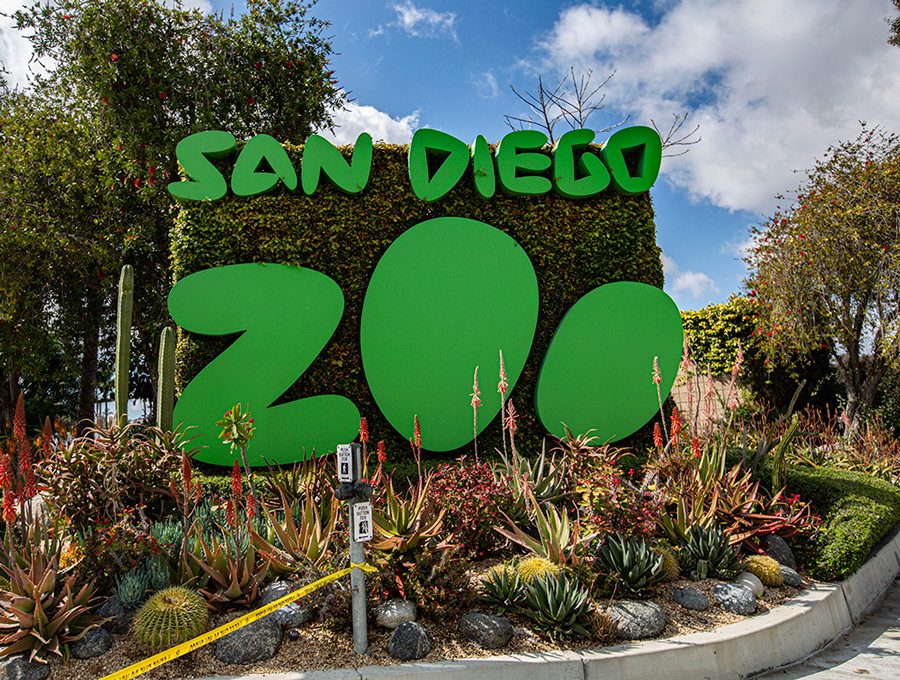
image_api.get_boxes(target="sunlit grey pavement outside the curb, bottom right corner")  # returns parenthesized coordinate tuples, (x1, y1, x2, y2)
(757, 580, 900, 680)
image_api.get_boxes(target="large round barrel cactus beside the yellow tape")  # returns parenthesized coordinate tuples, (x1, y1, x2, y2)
(133, 586, 209, 647)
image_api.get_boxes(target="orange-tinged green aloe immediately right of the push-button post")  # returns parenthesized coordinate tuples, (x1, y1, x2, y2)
(369, 477, 444, 553)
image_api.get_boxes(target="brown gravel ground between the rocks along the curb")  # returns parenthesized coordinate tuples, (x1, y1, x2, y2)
(51, 580, 809, 680)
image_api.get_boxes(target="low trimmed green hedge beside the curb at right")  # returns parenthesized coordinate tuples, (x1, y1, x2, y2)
(787, 466, 900, 580)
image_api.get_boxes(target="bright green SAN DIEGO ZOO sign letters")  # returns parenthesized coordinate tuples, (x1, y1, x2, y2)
(168, 127, 682, 465)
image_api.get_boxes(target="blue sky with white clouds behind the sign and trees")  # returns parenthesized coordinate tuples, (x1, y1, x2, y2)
(0, 0, 900, 309)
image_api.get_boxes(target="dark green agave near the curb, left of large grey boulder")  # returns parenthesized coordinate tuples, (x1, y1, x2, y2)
(522, 574, 591, 637)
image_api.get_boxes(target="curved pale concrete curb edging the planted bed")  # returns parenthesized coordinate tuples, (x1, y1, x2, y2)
(193, 525, 900, 680)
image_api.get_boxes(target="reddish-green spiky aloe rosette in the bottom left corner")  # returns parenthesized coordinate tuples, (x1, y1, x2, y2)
(0, 548, 103, 662)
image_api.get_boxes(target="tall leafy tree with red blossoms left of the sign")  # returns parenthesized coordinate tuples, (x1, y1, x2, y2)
(0, 0, 345, 428)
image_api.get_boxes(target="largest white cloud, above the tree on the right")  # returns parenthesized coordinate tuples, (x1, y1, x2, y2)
(535, 0, 900, 213)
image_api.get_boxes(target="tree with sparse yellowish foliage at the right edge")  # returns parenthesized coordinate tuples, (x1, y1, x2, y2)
(745, 123, 900, 431)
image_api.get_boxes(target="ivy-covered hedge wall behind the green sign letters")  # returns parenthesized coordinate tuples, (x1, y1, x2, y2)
(172, 144, 663, 455)
